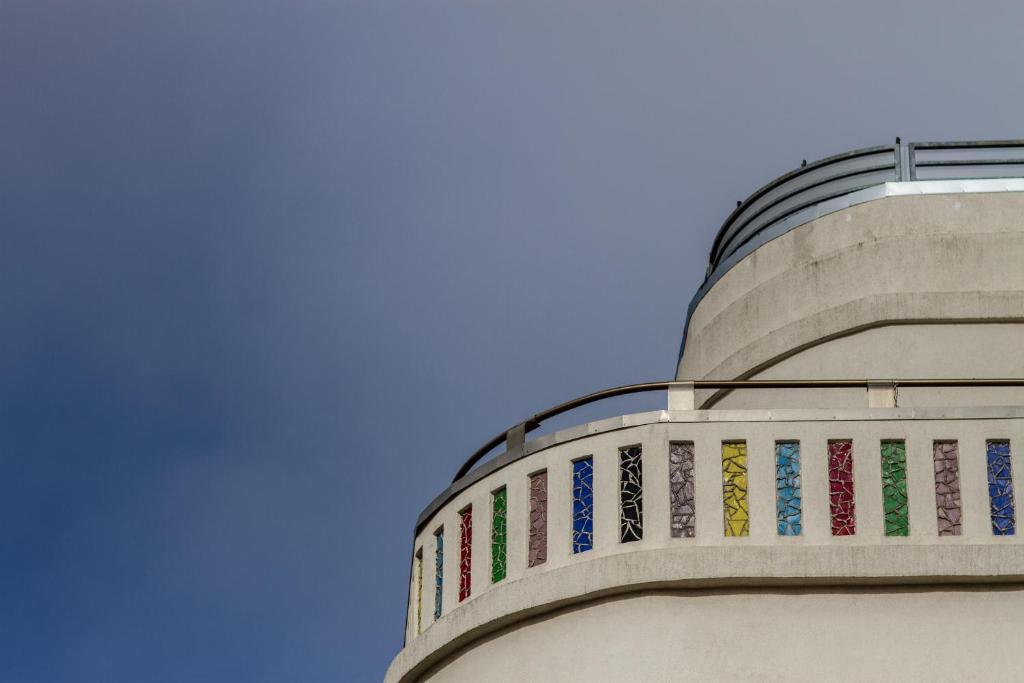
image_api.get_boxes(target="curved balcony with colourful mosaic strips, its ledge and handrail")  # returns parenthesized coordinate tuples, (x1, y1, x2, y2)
(388, 379, 1024, 681)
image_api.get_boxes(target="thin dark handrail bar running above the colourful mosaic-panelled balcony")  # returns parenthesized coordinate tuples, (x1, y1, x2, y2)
(452, 378, 1024, 483)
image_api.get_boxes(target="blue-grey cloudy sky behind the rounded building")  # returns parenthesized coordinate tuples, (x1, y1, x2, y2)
(0, 0, 1024, 683)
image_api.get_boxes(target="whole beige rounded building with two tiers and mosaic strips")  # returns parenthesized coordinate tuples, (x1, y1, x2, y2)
(386, 139, 1024, 681)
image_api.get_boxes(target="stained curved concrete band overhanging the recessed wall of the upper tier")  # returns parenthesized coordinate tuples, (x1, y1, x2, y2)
(677, 193, 1024, 379)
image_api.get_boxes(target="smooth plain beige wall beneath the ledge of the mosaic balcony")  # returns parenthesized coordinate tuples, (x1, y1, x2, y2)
(422, 586, 1024, 683)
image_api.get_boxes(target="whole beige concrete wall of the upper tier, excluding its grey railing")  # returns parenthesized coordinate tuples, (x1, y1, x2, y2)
(677, 193, 1024, 408)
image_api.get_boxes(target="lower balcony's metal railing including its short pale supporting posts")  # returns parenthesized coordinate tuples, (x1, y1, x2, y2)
(452, 378, 1024, 484)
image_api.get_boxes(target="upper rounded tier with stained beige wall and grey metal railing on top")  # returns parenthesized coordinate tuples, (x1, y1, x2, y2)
(676, 140, 1024, 409)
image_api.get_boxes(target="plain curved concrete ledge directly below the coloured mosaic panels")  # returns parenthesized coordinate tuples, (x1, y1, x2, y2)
(385, 540, 1024, 682)
